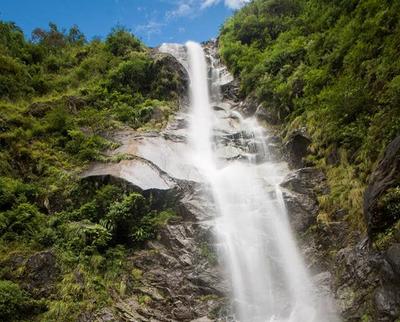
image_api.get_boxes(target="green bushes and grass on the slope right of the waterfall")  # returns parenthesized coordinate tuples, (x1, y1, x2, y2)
(220, 0, 400, 230)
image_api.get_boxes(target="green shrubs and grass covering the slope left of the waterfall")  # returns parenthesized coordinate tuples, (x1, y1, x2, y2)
(0, 21, 182, 321)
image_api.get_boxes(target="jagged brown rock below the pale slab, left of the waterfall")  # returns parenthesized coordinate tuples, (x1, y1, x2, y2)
(79, 177, 229, 322)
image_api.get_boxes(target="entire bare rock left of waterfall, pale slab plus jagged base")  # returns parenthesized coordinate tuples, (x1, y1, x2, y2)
(80, 78, 228, 322)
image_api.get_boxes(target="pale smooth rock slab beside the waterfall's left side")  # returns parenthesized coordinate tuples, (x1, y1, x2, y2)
(81, 128, 199, 191)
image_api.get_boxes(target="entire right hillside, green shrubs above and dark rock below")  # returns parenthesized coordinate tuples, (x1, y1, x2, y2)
(219, 0, 400, 321)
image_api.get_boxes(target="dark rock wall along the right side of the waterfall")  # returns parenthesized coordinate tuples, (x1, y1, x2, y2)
(226, 52, 400, 321)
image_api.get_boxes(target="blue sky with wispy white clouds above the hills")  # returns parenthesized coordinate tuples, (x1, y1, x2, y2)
(0, 0, 249, 46)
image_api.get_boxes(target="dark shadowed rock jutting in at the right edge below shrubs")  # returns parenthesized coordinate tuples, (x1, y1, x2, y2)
(364, 136, 400, 237)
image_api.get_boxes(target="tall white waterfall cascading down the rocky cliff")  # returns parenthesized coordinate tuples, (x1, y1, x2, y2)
(160, 42, 338, 322)
